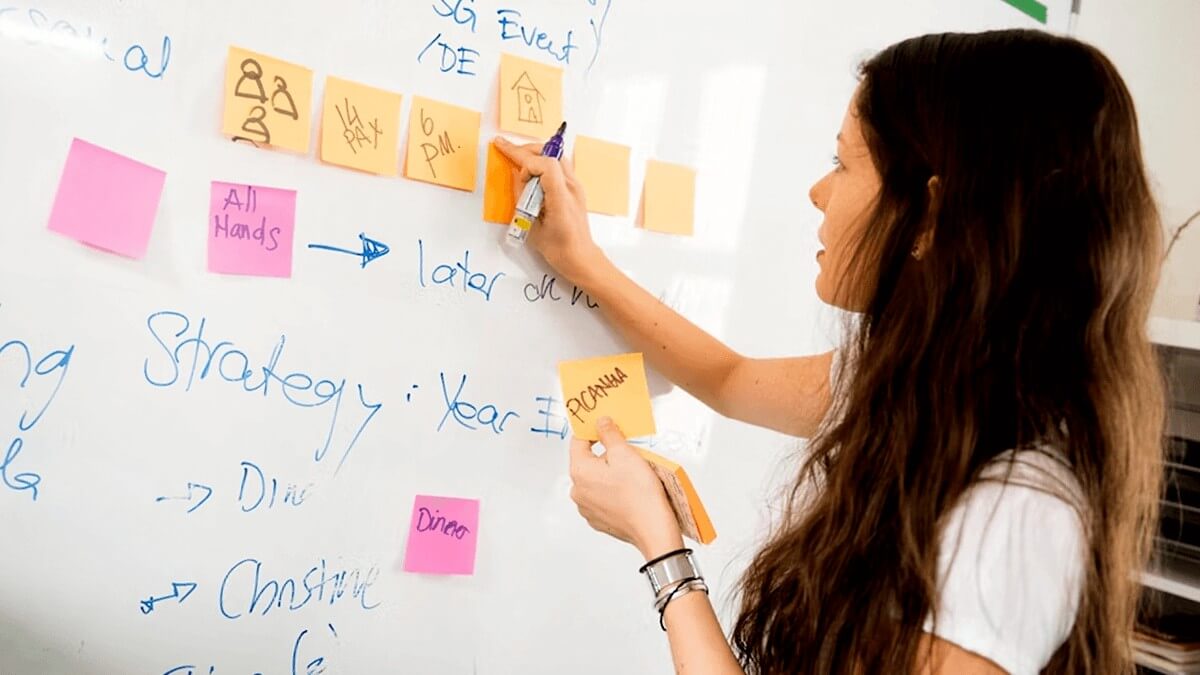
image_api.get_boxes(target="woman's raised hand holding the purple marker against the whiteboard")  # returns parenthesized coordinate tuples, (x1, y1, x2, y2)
(496, 136, 604, 286)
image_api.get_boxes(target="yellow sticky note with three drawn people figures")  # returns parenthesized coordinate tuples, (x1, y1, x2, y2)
(221, 47, 312, 153)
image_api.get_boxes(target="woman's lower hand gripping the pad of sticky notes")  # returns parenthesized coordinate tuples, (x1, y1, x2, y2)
(571, 418, 683, 560)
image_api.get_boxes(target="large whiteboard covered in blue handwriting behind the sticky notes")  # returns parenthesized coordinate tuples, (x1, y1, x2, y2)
(0, 0, 1104, 675)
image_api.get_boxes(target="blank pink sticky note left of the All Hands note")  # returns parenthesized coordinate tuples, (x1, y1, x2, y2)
(50, 138, 167, 258)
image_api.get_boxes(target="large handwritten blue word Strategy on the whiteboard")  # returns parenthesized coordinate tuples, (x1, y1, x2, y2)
(142, 311, 383, 476)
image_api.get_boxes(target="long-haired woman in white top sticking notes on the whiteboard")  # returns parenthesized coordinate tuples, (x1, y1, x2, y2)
(500, 30, 1164, 675)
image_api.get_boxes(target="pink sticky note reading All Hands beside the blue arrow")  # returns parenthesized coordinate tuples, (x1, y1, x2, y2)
(209, 180, 296, 276)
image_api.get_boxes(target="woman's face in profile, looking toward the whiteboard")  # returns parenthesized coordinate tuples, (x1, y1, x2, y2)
(809, 95, 882, 312)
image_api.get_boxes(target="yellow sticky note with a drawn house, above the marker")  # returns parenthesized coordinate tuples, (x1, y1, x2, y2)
(499, 54, 563, 141)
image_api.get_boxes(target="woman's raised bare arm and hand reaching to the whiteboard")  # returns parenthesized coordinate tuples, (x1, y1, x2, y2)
(496, 137, 833, 437)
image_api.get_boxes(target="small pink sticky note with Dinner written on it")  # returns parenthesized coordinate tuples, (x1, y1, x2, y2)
(404, 495, 479, 574)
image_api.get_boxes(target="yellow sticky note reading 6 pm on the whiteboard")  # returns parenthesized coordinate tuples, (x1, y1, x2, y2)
(404, 96, 480, 192)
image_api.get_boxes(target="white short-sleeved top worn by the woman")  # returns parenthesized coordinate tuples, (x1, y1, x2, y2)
(830, 350, 1087, 675)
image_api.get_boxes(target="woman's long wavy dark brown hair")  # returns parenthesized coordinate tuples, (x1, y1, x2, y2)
(733, 30, 1164, 675)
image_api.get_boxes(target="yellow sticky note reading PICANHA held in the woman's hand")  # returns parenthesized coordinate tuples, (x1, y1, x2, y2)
(558, 353, 654, 441)
